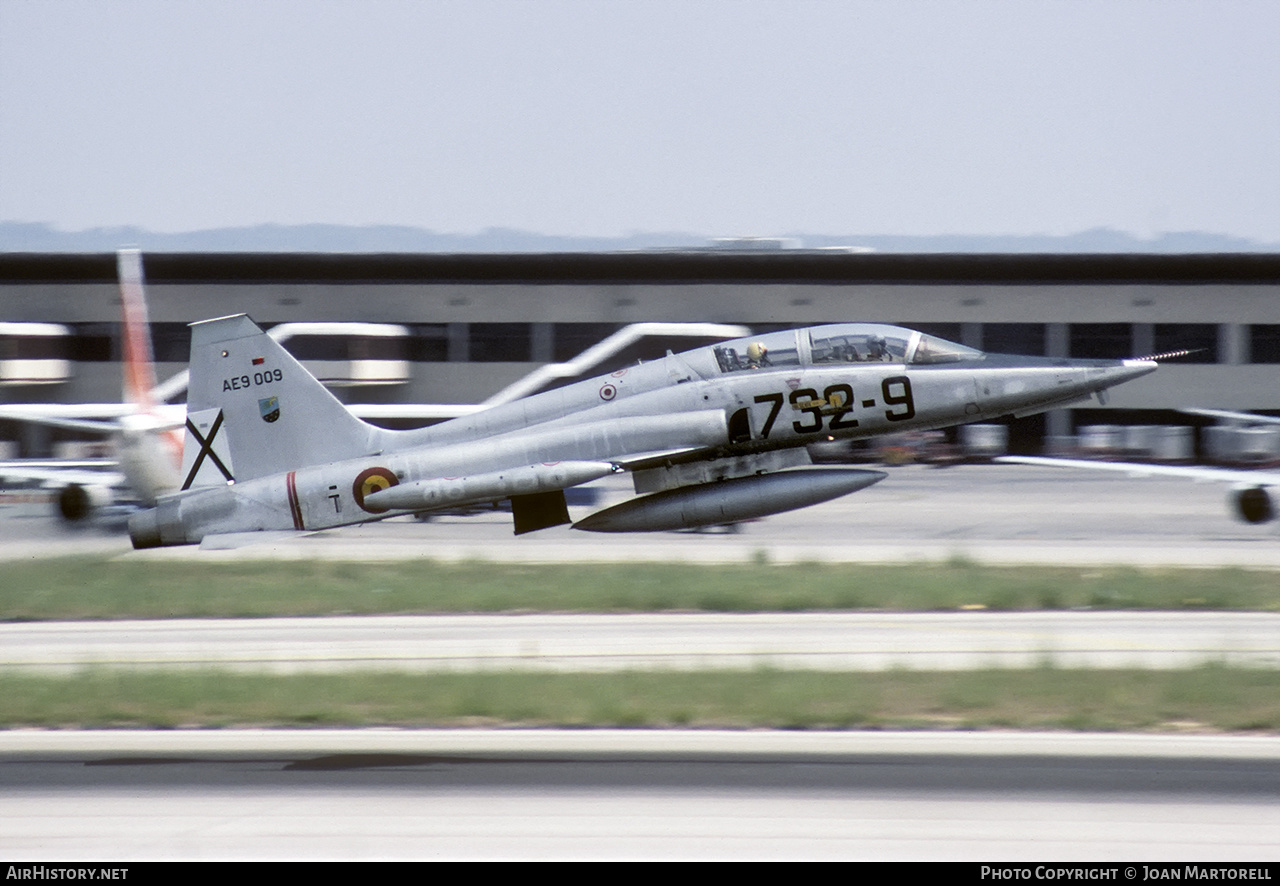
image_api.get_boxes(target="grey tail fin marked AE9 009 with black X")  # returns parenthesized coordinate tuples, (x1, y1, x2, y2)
(182, 314, 387, 489)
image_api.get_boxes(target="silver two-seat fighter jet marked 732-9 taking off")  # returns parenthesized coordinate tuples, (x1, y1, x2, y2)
(129, 314, 1156, 548)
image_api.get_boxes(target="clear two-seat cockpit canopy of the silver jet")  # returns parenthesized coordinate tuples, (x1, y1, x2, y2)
(714, 323, 983, 373)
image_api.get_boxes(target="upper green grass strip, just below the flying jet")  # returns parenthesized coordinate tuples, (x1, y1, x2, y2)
(0, 557, 1280, 621)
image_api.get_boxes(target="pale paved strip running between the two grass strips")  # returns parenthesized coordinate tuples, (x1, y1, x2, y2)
(0, 612, 1280, 672)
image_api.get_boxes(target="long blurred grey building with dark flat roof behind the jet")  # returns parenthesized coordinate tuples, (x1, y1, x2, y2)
(0, 250, 1280, 455)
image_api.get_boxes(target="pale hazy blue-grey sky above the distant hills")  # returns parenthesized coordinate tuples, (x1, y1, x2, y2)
(0, 0, 1280, 241)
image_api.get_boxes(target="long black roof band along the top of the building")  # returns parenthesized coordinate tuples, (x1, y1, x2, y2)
(0, 251, 1280, 286)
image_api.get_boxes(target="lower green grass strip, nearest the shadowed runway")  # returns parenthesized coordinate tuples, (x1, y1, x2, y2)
(0, 665, 1280, 732)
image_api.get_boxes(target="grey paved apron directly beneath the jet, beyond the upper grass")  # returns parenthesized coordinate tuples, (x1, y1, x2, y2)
(0, 465, 1280, 568)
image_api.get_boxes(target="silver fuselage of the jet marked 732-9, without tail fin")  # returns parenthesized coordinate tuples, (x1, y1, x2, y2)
(132, 324, 1155, 544)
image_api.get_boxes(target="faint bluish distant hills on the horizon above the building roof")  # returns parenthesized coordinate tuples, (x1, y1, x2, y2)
(0, 222, 1280, 254)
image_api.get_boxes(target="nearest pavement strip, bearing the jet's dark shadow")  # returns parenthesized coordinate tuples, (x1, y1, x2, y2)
(0, 731, 1280, 863)
